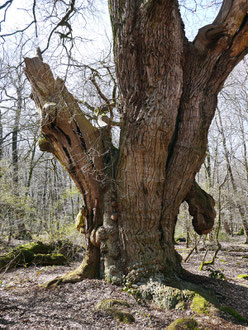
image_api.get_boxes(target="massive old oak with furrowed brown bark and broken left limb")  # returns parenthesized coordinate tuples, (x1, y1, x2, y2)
(22, 0, 248, 283)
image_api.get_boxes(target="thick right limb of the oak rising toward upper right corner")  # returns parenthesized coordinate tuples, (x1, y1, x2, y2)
(164, 0, 248, 222)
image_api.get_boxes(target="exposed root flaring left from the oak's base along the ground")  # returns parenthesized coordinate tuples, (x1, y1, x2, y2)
(43, 245, 100, 288)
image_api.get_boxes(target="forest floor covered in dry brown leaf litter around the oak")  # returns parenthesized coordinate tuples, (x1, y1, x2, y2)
(0, 238, 248, 329)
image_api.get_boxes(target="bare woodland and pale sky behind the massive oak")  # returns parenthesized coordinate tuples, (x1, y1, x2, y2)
(0, 1, 248, 243)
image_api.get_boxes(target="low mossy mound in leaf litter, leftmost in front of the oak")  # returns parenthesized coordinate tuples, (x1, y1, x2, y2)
(95, 299, 135, 323)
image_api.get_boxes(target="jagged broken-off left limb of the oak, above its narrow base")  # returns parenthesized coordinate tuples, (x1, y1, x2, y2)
(25, 58, 106, 213)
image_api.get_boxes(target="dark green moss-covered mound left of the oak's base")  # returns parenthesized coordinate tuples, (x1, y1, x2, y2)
(0, 242, 67, 272)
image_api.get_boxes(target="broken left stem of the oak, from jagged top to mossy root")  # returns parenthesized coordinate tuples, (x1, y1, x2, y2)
(24, 57, 112, 285)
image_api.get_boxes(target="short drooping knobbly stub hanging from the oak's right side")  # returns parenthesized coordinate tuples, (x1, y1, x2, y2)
(185, 182, 216, 235)
